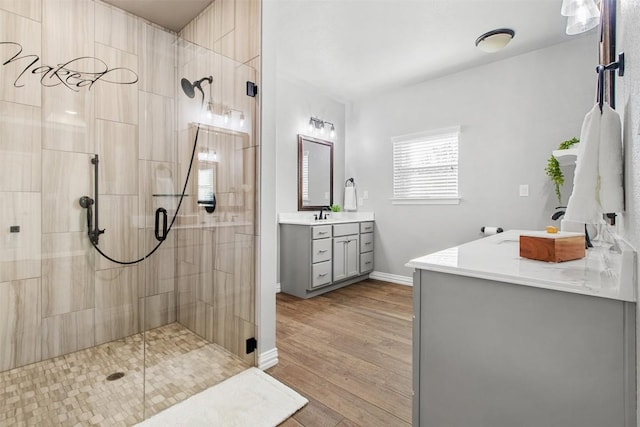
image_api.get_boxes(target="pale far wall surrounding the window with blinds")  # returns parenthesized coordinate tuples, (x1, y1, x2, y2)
(346, 32, 597, 276)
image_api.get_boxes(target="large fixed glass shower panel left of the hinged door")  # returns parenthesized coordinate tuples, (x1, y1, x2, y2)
(0, 0, 144, 425)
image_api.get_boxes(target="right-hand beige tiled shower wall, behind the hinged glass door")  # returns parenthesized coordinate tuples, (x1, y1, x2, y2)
(176, 0, 260, 364)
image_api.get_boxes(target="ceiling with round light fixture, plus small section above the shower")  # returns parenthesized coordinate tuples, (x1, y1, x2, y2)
(107, 0, 592, 101)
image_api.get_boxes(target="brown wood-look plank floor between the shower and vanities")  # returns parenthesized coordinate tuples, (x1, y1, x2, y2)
(267, 280, 412, 427)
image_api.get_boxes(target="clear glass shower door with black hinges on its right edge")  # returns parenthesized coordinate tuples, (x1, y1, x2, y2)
(141, 40, 257, 417)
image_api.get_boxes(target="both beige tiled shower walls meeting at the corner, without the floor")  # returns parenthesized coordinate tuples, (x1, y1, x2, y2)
(0, 0, 260, 370)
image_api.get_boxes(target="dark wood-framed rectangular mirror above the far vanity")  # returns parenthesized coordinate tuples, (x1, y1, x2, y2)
(298, 135, 333, 211)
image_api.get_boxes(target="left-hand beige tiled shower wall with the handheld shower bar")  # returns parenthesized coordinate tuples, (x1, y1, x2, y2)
(0, 0, 176, 370)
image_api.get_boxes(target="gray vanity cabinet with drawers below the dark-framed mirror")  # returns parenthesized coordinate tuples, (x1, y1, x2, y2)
(280, 221, 373, 298)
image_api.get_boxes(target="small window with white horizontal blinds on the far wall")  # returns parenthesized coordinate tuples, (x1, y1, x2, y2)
(391, 127, 460, 204)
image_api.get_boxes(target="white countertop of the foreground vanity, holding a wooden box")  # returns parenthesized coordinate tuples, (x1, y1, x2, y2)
(407, 230, 636, 302)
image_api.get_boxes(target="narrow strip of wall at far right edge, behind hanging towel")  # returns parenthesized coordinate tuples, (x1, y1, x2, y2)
(616, 0, 640, 419)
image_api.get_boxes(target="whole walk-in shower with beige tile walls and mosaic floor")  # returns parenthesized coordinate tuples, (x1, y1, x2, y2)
(0, 0, 259, 426)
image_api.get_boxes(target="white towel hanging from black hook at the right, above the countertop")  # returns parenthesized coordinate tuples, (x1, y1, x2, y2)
(565, 104, 624, 224)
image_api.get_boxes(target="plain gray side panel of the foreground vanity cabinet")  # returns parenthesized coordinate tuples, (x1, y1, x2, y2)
(413, 270, 636, 427)
